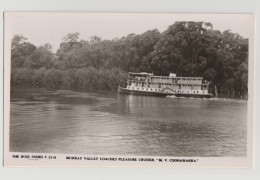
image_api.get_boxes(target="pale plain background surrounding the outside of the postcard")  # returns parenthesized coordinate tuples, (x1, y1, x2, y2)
(0, 0, 260, 179)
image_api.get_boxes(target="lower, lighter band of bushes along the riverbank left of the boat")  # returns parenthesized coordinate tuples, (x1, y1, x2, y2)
(11, 67, 127, 91)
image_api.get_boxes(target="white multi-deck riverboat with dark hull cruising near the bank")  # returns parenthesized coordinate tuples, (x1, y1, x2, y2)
(118, 72, 212, 98)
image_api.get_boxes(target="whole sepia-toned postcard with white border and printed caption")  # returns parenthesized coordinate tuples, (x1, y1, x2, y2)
(4, 12, 254, 167)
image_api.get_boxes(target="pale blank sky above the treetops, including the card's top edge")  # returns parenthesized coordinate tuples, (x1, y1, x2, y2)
(4, 12, 253, 52)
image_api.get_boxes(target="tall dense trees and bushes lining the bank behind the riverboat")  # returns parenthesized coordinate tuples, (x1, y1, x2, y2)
(11, 22, 248, 97)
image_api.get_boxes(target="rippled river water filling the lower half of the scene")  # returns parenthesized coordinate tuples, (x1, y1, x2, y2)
(10, 89, 247, 157)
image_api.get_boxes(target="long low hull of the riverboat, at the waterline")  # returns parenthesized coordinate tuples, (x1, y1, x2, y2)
(118, 87, 212, 98)
